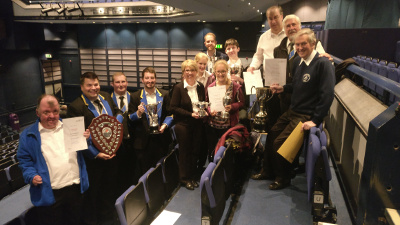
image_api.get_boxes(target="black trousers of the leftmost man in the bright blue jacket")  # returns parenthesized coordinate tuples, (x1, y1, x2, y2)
(37, 184, 83, 225)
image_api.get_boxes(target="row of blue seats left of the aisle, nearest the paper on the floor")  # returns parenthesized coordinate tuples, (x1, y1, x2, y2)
(115, 149, 179, 225)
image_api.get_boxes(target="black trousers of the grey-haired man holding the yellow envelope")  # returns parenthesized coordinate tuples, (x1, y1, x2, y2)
(263, 109, 311, 179)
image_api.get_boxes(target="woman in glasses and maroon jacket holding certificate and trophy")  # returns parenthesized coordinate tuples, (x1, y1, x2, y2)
(206, 60, 244, 162)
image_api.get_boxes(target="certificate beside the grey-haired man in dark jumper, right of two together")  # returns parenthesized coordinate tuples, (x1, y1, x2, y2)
(264, 59, 287, 86)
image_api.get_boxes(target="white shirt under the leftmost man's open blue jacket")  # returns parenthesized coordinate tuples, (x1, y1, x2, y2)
(39, 121, 80, 189)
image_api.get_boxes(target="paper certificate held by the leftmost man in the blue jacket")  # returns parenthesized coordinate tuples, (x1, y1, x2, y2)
(62, 116, 88, 152)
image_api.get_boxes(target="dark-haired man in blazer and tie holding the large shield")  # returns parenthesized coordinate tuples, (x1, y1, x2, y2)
(67, 72, 122, 224)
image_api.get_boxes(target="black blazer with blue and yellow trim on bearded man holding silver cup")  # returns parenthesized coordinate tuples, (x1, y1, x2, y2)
(129, 89, 172, 149)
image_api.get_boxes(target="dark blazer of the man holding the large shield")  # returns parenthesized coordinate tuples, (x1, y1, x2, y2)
(67, 91, 122, 129)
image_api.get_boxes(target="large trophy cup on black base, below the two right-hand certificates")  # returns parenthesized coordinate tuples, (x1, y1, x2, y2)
(253, 87, 272, 133)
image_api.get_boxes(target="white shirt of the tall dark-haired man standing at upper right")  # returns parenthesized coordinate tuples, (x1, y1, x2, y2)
(250, 29, 286, 71)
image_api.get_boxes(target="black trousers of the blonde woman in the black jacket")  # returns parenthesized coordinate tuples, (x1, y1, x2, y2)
(175, 120, 203, 181)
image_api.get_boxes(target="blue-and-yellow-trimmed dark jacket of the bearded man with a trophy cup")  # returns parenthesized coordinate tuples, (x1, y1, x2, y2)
(129, 88, 173, 149)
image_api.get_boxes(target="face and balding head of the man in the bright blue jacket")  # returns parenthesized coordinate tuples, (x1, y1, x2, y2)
(36, 96, 60, 129)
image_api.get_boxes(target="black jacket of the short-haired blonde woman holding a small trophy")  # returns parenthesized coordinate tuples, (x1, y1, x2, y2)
(170, 82, 206, 125)
